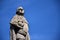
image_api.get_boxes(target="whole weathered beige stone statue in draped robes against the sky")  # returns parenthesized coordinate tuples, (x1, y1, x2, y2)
(10, 7, 30, 40)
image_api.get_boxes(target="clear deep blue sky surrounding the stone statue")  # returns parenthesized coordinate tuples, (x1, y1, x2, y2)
(0, 0, 60, 40)
